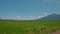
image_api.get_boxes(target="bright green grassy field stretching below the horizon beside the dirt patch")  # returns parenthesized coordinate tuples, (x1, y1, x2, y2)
(0, 20, 60, 34)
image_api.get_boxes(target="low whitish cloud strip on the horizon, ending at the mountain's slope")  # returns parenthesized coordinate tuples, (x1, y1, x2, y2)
(1, 16, 47, 20)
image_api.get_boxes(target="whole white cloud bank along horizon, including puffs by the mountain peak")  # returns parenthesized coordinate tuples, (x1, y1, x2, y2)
(0, 12, 60, 20)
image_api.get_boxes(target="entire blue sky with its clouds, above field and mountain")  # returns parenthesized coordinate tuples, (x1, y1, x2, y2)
(0, 0, 60, 19)
